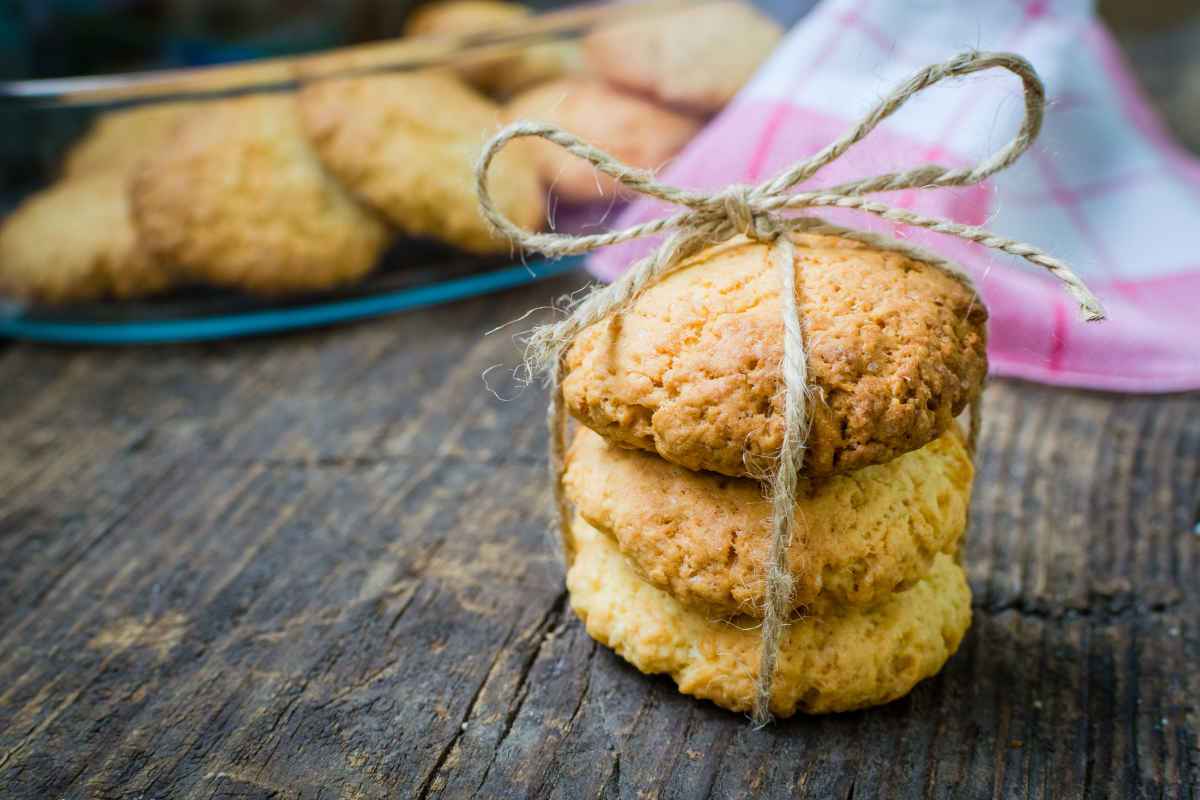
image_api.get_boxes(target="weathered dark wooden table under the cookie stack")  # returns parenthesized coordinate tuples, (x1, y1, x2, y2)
(0, 15, 1200, 799)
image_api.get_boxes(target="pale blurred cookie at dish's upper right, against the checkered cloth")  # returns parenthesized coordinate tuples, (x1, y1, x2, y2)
(583, 2, 784, 112)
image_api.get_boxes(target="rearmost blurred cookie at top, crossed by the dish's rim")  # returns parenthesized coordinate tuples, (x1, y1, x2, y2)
(404, 0, 583, 96)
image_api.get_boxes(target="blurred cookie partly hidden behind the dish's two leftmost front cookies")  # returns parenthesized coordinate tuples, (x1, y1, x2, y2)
(62, 103, 196, 178)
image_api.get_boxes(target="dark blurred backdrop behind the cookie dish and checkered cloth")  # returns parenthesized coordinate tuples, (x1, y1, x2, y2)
(0, 0, 1200, 204)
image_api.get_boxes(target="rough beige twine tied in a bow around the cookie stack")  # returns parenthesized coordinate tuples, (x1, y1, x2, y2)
(475, 52, 1104, 726)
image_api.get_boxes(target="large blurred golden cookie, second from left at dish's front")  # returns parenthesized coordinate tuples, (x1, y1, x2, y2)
(131, 95, 389, 295)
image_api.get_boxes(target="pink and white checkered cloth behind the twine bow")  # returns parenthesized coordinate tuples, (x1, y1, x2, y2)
(590, 0, 1200, 392)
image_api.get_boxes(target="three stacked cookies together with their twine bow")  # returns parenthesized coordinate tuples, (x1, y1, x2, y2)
(476, 53, 1104, 724)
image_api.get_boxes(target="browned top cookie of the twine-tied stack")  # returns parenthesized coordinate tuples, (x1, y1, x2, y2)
(563, 236, 988, 477)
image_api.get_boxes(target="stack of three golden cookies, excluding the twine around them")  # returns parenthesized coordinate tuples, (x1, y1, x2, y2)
(563, 236, 986, 716)
